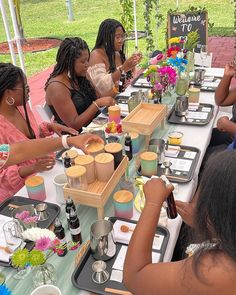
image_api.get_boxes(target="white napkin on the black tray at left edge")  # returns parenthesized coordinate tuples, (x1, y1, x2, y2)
(0, 214, 22, 262)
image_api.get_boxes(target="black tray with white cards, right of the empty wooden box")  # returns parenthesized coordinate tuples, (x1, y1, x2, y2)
(167, 103, 214, 126)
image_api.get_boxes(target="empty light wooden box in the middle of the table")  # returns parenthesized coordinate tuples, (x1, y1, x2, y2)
(122, 103, 167, 135)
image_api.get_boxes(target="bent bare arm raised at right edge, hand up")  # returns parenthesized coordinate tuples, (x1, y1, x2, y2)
(215, 64, 236, 106)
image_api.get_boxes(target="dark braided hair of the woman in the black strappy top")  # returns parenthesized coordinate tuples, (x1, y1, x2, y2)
(45, 37, 89, 88)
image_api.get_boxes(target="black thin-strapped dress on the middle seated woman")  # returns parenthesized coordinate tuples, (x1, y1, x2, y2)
(48, 77, 99, 132)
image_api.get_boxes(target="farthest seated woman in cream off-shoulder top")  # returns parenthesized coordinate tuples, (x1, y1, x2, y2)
(88, 19, 141, 96)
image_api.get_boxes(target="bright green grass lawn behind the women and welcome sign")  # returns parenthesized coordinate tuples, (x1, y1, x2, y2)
(0, 0, 234, 76)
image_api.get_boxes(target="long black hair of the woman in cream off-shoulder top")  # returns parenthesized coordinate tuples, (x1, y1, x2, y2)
(94, 19, 125, 73)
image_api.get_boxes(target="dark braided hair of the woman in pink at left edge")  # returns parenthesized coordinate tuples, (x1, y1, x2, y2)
(0, 63, 35, 139)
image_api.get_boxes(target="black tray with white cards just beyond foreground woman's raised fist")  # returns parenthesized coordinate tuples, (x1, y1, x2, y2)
(137, 145, 201, 183)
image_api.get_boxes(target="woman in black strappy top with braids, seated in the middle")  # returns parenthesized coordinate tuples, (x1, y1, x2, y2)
(45, 38, 115, 131)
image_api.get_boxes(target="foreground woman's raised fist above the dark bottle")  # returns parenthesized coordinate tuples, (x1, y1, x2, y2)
(143, 178, 174, 205)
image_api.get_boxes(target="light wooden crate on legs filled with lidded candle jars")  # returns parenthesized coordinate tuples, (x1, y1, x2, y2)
(63, 156, 128, 219)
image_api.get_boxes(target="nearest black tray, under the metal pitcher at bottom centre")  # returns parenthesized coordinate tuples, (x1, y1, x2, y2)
(71, 217, 170, 295)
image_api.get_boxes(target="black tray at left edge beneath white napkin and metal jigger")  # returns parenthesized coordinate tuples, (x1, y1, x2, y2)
(0, 196, 61, 266)
